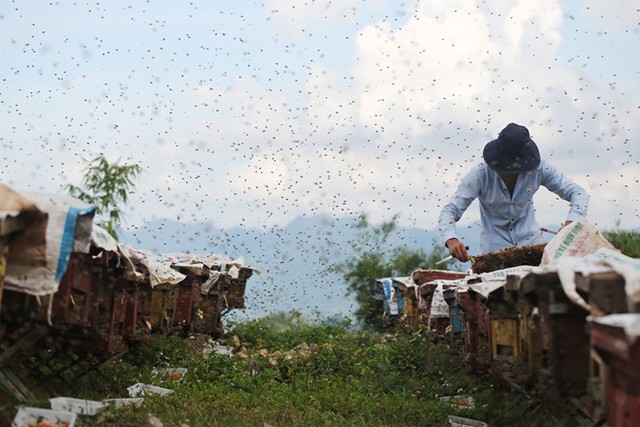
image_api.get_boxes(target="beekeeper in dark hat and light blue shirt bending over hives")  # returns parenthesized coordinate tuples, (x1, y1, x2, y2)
(438, 123, 589, 262)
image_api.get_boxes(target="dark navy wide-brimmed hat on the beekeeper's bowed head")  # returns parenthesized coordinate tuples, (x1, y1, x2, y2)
(482, 123, 540, 174)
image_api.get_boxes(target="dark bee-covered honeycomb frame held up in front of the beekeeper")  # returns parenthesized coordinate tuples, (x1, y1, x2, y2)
(471, 243, 547, 274)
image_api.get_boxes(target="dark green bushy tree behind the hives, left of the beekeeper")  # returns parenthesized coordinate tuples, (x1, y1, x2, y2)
(336, 213, 446, 329)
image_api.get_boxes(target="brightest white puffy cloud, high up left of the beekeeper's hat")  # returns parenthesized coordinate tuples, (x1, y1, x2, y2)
(354, 4, 498, 133)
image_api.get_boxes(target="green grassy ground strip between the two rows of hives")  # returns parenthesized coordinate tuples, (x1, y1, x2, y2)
(31, 314, 556, 427)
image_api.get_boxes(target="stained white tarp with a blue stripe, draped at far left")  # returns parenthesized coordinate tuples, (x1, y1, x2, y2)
(0, 189, 95, 295)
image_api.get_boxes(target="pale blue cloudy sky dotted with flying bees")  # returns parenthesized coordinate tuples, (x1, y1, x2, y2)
(0, 0, 640, 241)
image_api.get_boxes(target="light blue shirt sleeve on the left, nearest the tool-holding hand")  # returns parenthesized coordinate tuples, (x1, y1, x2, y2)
(438, 167, 480, 247)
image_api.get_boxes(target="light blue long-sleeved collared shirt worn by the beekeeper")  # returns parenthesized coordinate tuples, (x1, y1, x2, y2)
(438, 160, 589, 253)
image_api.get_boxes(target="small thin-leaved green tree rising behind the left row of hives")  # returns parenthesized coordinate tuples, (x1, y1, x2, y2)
(65, 155, 141, 239)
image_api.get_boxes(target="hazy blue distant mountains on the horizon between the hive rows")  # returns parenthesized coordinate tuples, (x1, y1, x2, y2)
(119, 214, 478, 318)
